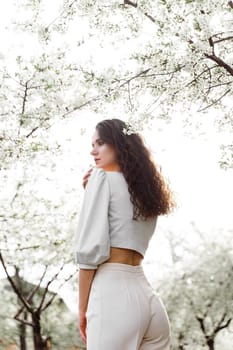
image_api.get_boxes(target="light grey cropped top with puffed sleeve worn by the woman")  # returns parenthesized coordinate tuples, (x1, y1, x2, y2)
(75, 168, 157, 269)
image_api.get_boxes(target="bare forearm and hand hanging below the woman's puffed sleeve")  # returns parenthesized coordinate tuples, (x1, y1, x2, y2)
(79, 269, 96, 343)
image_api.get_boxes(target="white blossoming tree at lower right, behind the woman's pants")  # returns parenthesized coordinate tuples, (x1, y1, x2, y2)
(162, 228, 233, 350)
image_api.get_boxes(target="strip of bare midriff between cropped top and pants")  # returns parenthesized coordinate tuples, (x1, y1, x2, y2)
(106, 247, 143, 266)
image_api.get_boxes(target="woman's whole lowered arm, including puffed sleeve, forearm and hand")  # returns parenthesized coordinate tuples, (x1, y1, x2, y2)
(74, 168, 110, 342)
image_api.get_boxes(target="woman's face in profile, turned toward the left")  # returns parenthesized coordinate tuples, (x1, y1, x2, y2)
(91, 130, 120, 171)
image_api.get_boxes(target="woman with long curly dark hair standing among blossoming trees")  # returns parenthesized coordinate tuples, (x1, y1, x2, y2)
(75, 119, 173, 350)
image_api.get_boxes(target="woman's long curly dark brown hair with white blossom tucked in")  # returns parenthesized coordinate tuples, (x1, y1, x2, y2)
(96, 119, 175, 220)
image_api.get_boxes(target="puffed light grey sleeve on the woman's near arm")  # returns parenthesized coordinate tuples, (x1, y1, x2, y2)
(75, 168, 110, 269)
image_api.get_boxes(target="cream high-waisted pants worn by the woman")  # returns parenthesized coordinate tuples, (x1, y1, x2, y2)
(87, 263, 170, 350)
